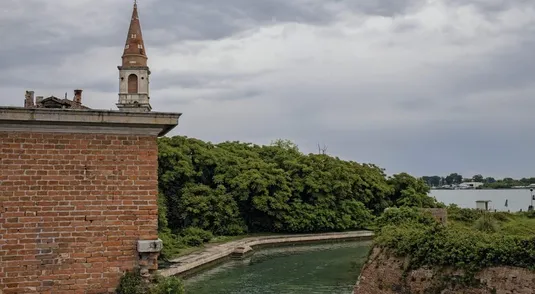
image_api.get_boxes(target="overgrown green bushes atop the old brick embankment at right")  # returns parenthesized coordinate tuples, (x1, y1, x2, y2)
(375, 207, 535, 273)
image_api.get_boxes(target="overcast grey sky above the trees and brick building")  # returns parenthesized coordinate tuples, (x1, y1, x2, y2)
(0, 0, 535, 178)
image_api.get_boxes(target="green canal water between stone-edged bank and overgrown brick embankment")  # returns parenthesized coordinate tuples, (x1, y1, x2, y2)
(185, 241, 371, 294)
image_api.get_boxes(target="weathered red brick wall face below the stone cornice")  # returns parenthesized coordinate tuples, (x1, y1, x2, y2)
(0, 132, 158, 294)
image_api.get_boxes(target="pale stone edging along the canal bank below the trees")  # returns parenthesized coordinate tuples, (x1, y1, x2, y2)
(158, 231, 374, 277)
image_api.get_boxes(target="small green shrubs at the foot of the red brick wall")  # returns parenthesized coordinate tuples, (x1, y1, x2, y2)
(116, 269, 184, 294)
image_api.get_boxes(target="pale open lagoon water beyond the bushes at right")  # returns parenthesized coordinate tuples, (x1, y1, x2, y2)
(431, 189, 535, 212)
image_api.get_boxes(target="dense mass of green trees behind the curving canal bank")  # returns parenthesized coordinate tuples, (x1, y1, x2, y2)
(159, 136, 442, 235)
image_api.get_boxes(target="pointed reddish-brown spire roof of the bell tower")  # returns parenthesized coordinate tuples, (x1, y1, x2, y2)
(122, 1, 148, 67)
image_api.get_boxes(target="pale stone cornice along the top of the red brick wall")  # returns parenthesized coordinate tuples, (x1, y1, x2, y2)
(0, 107, 182, 136)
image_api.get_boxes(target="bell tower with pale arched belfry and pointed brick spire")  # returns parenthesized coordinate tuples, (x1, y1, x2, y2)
(117, 2, 152, 112)
